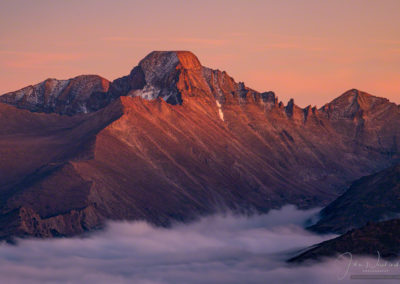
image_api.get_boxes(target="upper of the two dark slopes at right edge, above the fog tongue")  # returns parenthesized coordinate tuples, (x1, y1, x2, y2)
(310, 165, 400, 233)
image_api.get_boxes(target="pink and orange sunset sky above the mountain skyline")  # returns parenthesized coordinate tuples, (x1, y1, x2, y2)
(0, 0, 400, 106)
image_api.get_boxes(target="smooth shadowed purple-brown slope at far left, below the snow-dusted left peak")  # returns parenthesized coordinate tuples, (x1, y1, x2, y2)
(0, 98, 122, 195)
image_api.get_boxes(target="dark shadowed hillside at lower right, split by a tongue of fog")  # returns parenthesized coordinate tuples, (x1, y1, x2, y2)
(289, 164, 400, 262)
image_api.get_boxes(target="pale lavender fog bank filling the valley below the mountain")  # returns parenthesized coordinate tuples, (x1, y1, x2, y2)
(0, 206, 390, 284)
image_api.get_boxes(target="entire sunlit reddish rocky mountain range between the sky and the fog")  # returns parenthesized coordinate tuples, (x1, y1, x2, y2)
(0, 51, 400, 239)
